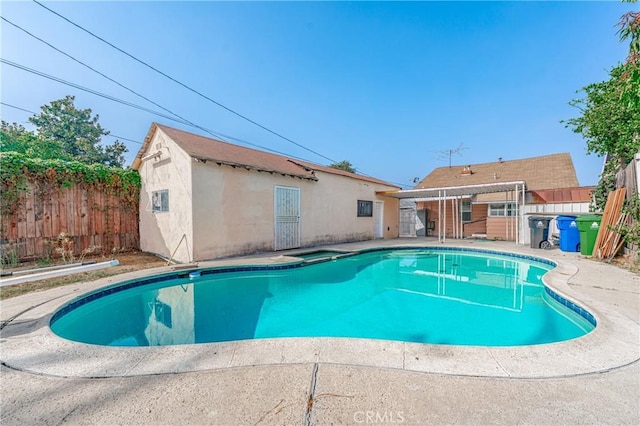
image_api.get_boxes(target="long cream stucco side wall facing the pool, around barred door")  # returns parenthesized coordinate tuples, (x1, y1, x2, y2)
(192, 160, 399, 260)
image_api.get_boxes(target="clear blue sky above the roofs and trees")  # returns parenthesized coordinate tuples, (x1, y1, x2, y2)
(0, 0, 637, 187)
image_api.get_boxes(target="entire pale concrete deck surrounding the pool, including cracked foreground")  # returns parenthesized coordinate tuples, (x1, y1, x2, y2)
(0, 239, 640, 424)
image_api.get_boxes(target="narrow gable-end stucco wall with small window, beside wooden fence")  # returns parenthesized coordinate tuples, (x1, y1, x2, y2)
(138, 129, 193, 262)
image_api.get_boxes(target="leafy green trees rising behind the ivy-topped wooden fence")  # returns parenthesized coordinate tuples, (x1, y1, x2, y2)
(8, 96, 127, 167)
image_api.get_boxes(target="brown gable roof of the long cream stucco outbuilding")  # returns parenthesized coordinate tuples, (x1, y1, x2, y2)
(132, 123, 398, 188)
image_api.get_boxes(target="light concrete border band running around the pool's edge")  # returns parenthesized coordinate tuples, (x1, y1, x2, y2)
(0, 244, 640, 378)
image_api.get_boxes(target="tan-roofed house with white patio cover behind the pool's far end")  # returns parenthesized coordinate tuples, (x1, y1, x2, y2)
(387, 153, 591, 243)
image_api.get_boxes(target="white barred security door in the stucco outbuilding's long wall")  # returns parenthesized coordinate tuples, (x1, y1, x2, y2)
(274, 186, 300, 250)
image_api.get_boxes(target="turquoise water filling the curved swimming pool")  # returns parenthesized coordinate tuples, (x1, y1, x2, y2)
(51, 249, 595, 346)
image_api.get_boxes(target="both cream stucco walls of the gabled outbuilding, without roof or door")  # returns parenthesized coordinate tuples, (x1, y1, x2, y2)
(139, 129, 399, 262)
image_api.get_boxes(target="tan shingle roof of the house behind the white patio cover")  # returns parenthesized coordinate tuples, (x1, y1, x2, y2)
(414, 153, 578, 190)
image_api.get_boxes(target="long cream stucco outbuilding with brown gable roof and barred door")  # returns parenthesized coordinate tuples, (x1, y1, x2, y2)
(133, 123, 399, 262)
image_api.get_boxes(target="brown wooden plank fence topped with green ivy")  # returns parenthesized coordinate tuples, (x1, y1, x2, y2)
(0, 182, 140, 262)
